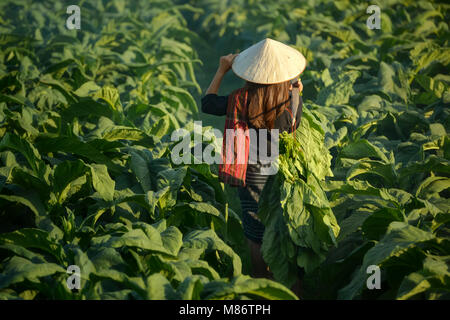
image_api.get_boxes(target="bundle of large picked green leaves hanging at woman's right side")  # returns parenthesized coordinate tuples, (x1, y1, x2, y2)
(258, 109, 339, 286)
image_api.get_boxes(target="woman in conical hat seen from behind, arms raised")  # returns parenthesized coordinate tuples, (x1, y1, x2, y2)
(202, 39, 306, 278)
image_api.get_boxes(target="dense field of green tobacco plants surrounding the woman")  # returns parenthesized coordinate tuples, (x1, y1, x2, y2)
(0, 0, 450, 300)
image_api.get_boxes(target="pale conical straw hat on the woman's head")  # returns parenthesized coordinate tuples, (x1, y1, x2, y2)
(232, 38, 306, 84)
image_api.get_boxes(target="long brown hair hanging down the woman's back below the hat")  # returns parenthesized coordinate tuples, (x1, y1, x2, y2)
(239, 81, 291, 129)
